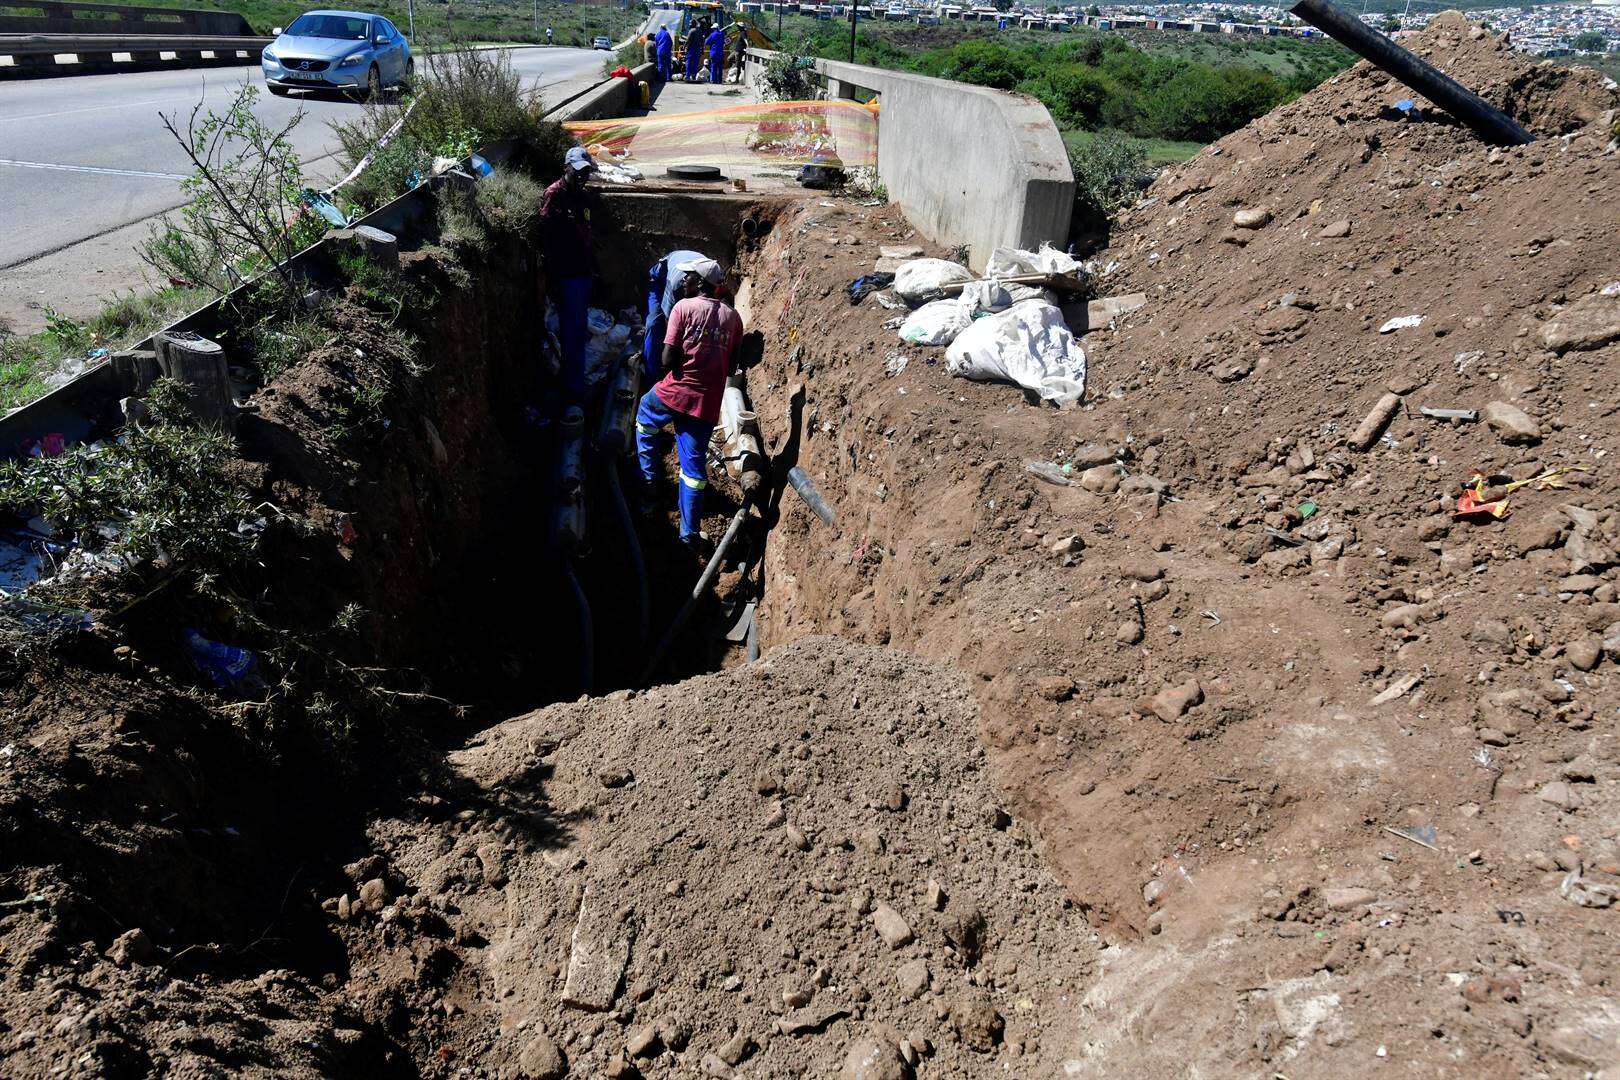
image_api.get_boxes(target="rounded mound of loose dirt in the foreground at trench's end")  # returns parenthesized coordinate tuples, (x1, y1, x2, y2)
(342, 638, 1092, 1077)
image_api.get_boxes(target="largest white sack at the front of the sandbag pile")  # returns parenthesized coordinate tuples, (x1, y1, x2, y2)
(944, 300, 1085, 403)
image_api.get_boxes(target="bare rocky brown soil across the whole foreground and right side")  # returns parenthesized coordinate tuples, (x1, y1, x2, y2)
(0, 16, 1620, 1078)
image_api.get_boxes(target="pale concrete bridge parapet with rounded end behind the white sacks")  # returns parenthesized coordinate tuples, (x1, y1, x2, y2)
(748, 49, 1074, 269)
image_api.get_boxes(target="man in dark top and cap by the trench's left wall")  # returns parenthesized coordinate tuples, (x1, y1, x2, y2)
(539, 146, 598, 405)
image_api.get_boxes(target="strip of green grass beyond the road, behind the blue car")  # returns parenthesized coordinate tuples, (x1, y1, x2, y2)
(109, 0, 645, 49)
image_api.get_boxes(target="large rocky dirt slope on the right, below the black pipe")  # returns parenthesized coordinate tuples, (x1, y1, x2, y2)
(741, 16, 1620, 1075)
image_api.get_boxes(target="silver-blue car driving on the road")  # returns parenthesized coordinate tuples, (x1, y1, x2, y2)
(261, 11, 416, 97)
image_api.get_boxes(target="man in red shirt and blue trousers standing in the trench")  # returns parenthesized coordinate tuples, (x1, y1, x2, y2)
(635, 259, 742, 555)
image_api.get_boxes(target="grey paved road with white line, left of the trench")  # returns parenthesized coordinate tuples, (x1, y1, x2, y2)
(0, 49, 608, 270)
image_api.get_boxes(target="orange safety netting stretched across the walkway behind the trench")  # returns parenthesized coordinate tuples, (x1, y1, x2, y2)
(562, 100, 878, 168)
